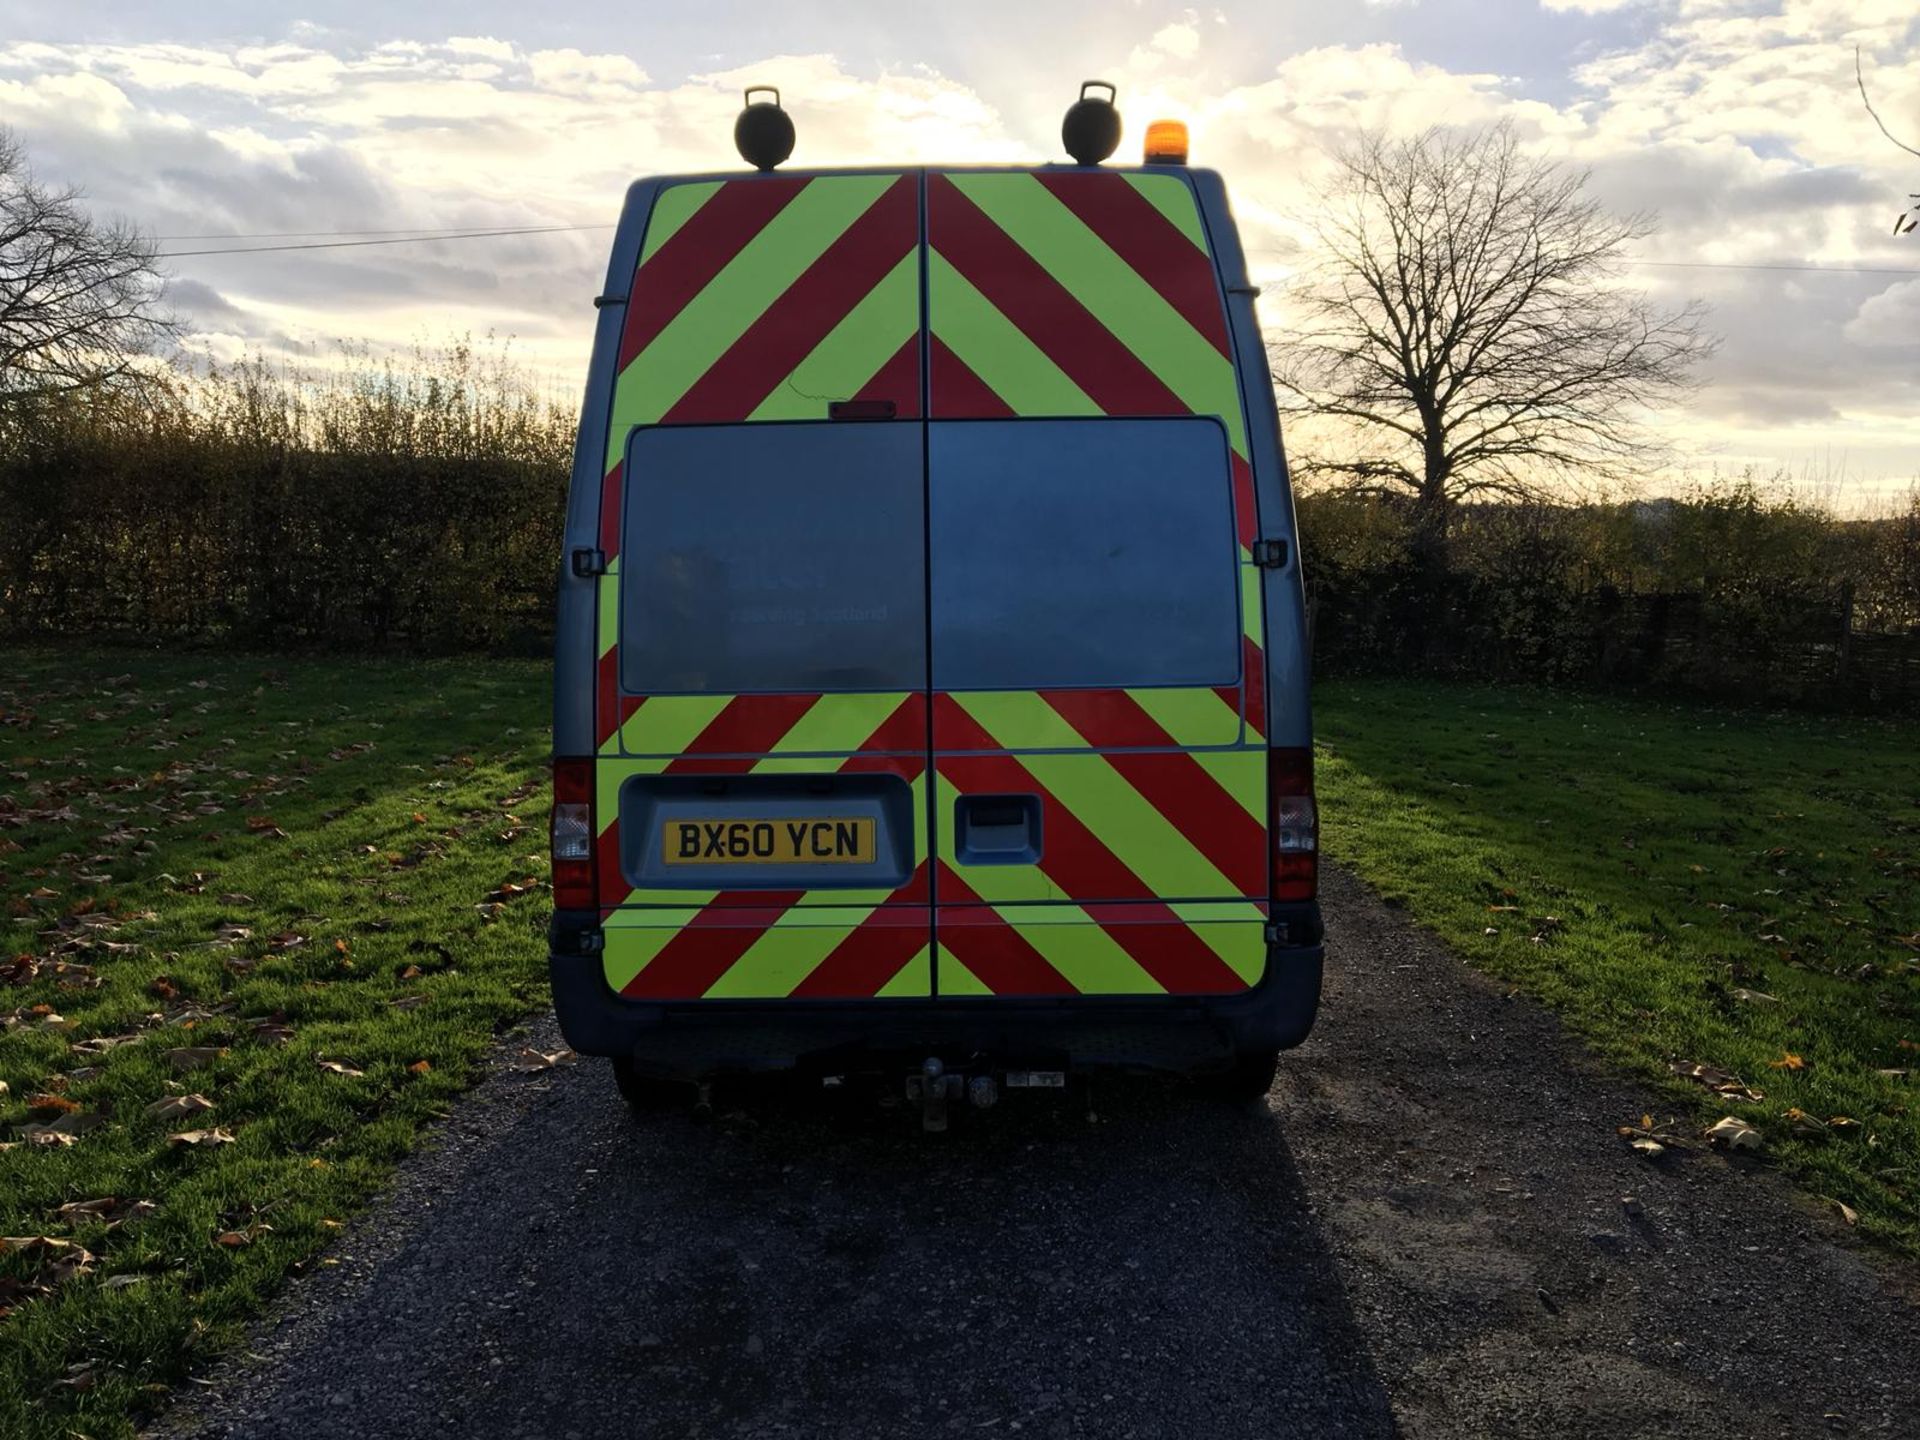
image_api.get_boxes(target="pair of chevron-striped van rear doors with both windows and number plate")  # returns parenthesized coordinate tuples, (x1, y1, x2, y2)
(593, 171, 1267, 1002)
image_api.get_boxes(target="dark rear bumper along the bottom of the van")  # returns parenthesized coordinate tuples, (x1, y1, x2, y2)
(549, 904, 1325, 1079)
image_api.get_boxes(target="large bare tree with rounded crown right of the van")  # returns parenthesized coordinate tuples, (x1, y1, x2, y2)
(1271, 125, 1713, 563)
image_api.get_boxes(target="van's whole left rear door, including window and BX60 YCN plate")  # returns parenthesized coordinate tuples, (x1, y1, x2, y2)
(595, 175, 933, 1000)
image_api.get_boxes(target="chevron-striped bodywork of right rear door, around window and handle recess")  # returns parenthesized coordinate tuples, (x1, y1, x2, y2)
(927, 171, 1267, 996)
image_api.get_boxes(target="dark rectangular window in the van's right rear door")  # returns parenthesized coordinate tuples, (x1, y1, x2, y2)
(927, 417, 1240, 689)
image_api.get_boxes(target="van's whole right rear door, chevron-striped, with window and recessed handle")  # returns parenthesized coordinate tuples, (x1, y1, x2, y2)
(927, 171, 1267, 996)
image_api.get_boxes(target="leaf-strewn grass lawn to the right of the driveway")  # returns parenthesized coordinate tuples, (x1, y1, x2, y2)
(1315, 682, 1920, 1254)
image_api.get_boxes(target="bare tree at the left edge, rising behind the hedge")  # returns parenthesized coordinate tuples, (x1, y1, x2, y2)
(0, 129, 179, 405)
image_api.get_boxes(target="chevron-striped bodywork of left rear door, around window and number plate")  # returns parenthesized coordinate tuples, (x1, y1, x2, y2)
(593, 173, 931, 1000)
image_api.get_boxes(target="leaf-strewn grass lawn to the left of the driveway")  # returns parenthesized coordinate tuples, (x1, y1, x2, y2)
(0, 651, 549, 1440)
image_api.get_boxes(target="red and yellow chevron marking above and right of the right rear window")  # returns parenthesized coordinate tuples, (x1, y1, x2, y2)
(927, 171, 1265, 737)
